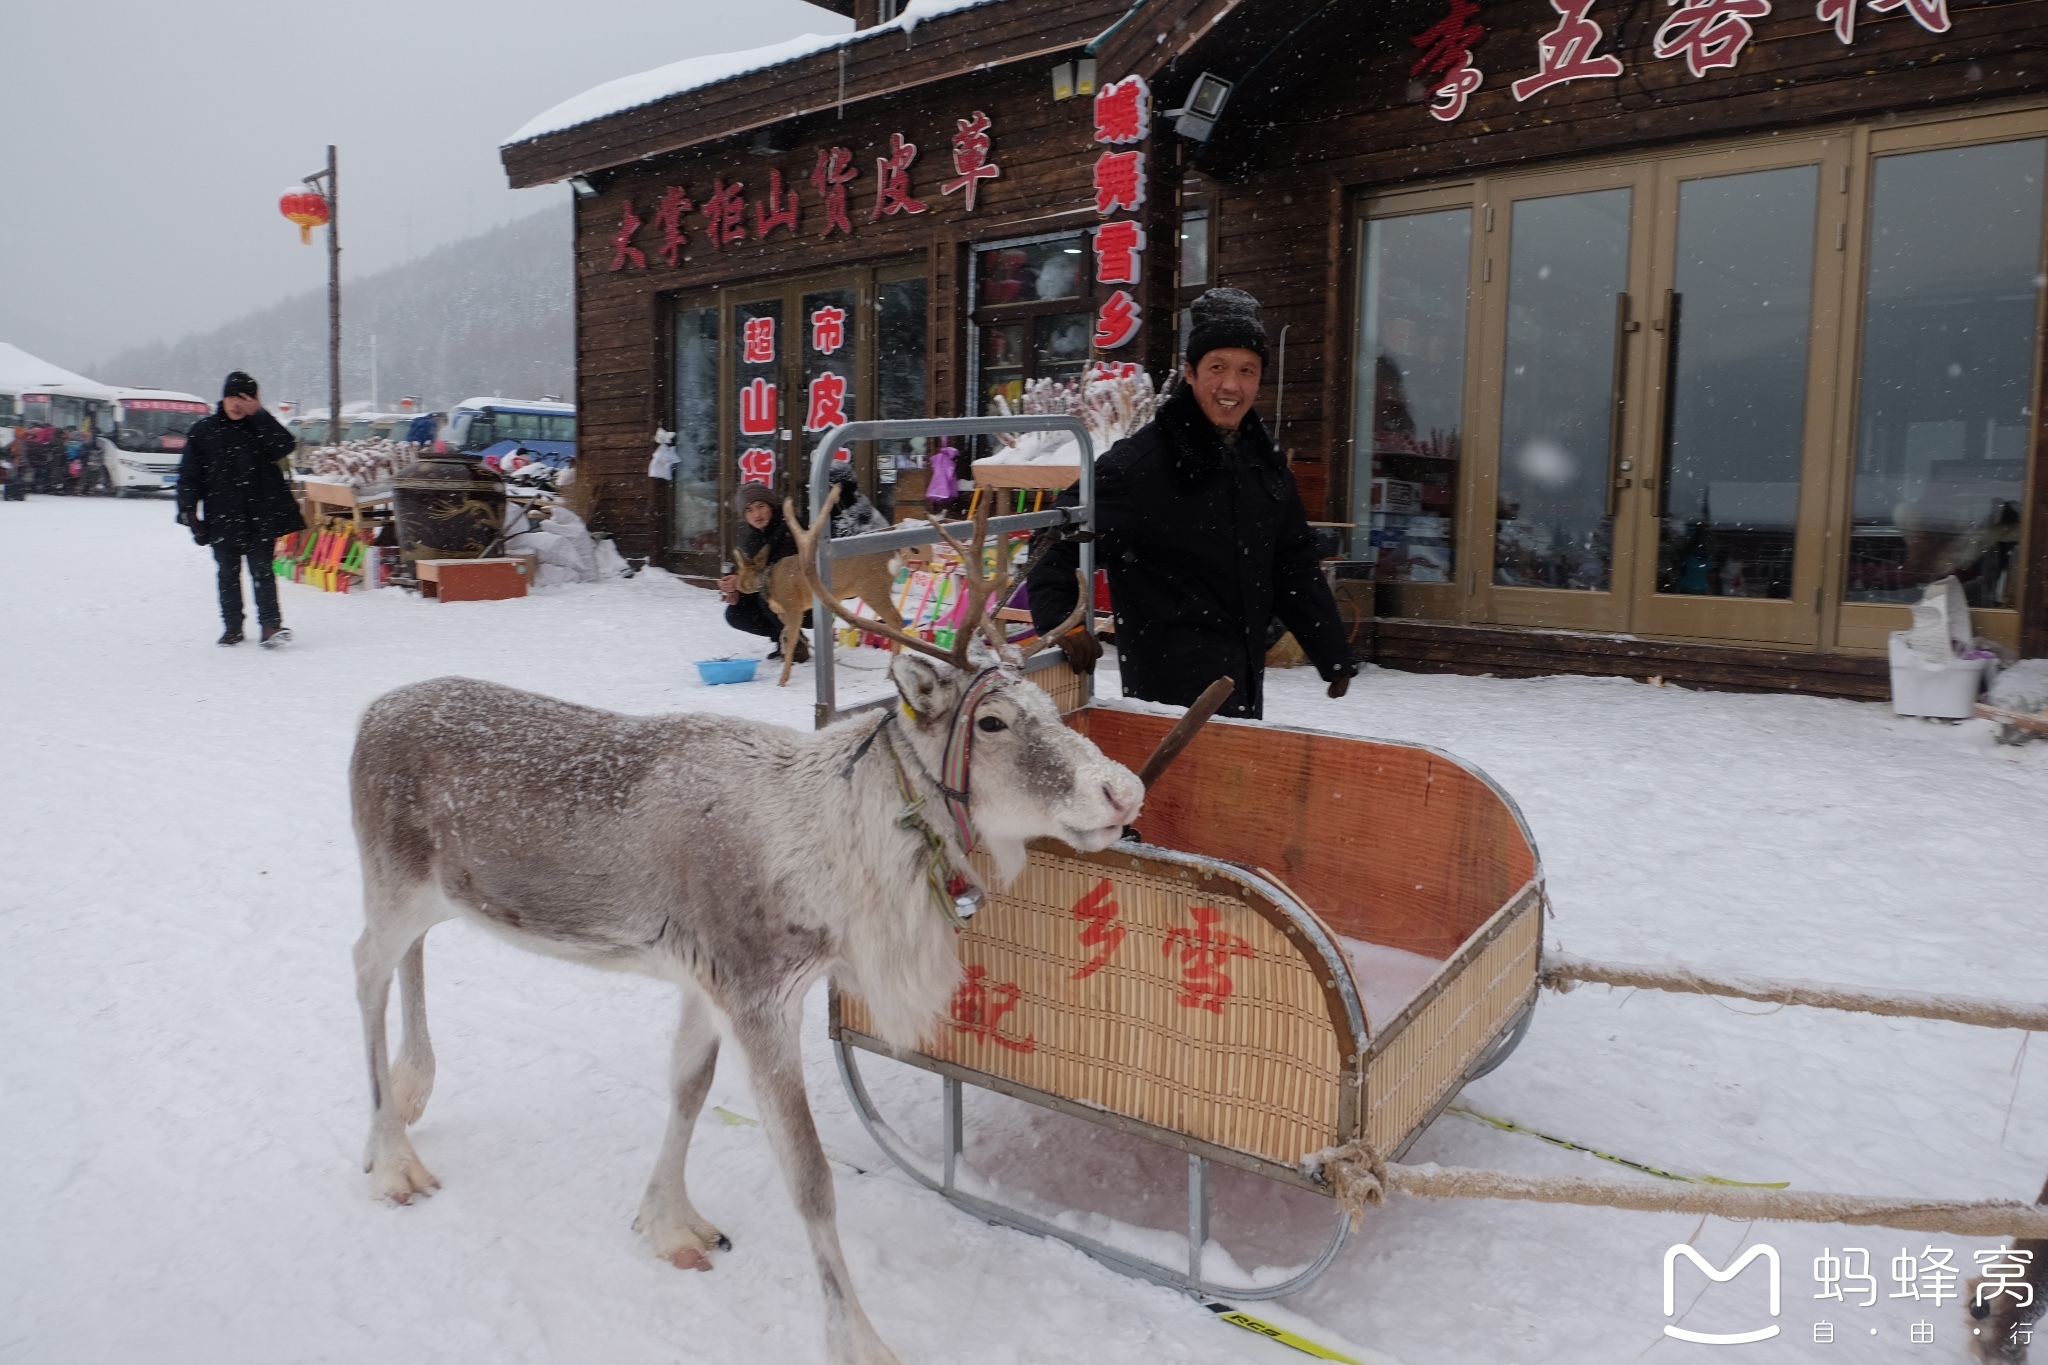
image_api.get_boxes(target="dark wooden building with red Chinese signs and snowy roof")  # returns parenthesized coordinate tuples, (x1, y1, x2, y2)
(504, 0, 2048, 698)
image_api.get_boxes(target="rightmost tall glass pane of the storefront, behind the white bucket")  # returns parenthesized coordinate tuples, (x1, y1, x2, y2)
(1847, 137, 2048, 608)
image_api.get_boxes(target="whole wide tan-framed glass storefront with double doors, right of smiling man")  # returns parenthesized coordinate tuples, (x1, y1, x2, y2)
(1348, 111, 2048, 651)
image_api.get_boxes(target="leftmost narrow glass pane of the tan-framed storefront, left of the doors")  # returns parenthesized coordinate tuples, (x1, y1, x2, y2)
(1350, 209, 1473, 583)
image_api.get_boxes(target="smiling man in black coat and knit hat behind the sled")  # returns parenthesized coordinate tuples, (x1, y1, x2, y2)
(1026, 289, 1358, 718)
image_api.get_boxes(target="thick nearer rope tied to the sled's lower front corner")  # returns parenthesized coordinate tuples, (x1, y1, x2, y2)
(1303, 1140, 2048, 1238)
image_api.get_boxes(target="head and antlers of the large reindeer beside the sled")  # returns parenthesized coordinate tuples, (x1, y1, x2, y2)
(788, 489, 1145, 882)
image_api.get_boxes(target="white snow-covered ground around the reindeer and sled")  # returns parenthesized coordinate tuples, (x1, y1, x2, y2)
(0, 497, 2048, 1365)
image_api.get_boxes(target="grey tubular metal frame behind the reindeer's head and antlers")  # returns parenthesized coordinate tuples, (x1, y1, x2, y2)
(811, 415, 1096, 729)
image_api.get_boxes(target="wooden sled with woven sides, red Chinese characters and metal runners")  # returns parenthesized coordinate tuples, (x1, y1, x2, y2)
(831, 679, 1544, 1300)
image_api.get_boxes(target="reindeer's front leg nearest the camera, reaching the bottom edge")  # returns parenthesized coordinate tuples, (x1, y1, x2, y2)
(733, 997, 897, 1365)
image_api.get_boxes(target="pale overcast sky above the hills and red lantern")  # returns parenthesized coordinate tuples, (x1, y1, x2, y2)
(0, 0, 852, 375)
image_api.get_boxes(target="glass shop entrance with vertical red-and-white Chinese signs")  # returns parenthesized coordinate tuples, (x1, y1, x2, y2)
(670, 264, 928, 573)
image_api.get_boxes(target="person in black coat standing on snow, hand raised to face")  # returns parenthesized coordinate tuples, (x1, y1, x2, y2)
(178, 370, 305, 649)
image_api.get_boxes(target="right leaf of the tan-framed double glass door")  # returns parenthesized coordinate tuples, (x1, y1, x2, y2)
(1616, 137, 1847, 645)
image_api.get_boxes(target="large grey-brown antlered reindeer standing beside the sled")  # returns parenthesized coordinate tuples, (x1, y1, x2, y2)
(350, 499, 1143, 1365)
